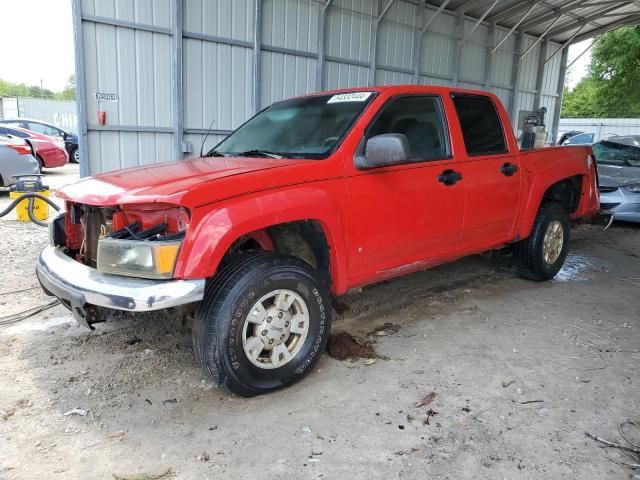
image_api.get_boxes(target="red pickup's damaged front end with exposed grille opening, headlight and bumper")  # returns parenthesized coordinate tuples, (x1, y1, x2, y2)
(36, 202, 204, 328)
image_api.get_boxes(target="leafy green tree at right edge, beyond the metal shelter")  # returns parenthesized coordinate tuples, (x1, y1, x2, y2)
(562, 26, 640, 118)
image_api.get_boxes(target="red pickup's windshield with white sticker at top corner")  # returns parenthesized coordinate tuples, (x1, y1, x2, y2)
(207, 92, 374, 158)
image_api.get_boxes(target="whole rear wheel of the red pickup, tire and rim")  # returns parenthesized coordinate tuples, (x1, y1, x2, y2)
(515, 202, 571, 281)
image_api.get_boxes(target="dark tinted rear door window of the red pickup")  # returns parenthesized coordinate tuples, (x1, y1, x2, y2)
(451, 93, 509, 157)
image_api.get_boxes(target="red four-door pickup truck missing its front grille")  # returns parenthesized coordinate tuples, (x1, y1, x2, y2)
(37, 85, 599, 396)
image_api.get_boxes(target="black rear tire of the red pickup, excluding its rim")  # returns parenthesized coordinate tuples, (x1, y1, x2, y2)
(514, 202, 571, 281)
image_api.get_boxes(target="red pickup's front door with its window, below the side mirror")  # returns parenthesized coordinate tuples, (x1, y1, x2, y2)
(346, 95, 465, 286)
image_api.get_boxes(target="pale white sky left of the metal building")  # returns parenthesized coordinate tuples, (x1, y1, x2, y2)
(0, 0, 74, 91)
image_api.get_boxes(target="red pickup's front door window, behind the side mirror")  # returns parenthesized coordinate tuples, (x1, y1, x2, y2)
(366, 95, 451, 163)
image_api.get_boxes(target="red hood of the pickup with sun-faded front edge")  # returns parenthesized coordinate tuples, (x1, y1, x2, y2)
(57, 157, 305, 205)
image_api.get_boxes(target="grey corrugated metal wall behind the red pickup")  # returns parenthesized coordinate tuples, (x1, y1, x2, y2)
(73, 0, 564, 174)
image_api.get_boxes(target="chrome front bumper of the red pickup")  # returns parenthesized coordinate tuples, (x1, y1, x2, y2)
(36, 245, 205, 328)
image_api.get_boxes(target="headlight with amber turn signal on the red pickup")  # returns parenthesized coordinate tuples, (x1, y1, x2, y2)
(97, 237, 182, 279)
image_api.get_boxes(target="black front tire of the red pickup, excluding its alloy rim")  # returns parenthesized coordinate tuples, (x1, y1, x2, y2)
(193, 252, 331, 397)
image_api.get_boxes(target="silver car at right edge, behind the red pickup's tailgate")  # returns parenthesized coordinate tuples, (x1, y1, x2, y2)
(592, 135, 640, 222)
